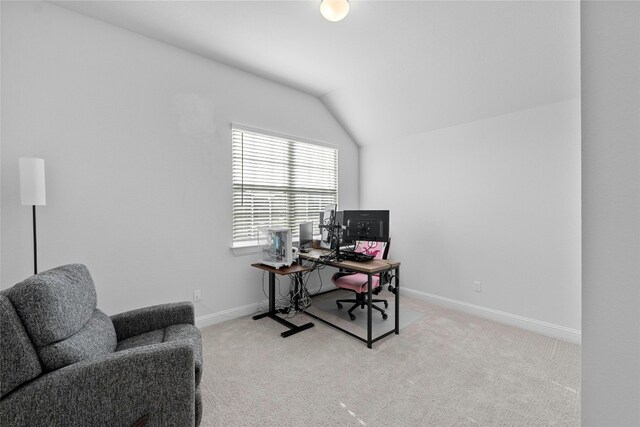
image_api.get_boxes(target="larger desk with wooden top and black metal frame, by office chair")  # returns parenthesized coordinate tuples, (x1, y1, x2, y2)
(299, 249, 400, 348)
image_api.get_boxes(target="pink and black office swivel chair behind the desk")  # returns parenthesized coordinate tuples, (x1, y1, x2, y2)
(331, 240, 391, 320)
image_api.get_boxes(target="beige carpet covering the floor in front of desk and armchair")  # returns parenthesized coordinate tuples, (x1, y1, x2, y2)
(201, 297, 580, 427)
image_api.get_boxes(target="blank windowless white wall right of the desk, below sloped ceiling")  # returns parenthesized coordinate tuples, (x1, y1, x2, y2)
(360, 100, 580, 340)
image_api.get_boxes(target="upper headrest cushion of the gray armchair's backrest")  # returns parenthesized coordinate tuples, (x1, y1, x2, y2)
(6, 264, 96, 347)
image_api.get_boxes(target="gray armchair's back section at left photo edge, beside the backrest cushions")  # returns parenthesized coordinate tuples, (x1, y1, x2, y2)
(0, 294, 42, 397)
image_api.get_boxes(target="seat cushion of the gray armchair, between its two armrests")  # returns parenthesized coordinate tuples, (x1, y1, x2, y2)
(116, 324, 202, 387)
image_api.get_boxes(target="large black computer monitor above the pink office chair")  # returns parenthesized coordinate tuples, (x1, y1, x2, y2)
(343, 210, 389, 244)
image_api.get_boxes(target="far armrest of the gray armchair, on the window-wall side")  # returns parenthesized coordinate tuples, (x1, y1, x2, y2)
(111, 301, 195, 341)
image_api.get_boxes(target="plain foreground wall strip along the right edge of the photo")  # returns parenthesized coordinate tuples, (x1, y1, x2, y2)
(581, 1, 640, 427)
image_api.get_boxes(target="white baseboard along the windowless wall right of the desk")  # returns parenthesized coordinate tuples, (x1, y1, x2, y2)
(400, 287, 582, 344)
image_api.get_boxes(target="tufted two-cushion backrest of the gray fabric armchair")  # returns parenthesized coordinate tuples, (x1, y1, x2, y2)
(3, 264, 117, 372)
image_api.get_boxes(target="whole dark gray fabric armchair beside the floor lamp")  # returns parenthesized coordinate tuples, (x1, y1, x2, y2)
(0, 264, 202, 427)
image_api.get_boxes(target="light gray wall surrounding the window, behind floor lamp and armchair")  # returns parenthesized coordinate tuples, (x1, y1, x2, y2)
(1, 2, 358, 316)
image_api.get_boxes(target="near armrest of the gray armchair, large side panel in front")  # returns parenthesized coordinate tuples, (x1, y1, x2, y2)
(0, 342, 195, 427)
